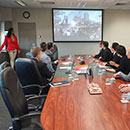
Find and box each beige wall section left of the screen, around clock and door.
[13,9,52,43]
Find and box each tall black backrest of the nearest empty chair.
[0,67,28,118]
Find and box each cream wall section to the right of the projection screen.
[103,10,130,48]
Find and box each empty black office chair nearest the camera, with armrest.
[0,67,42,130]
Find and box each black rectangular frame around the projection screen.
[52,8,104,43]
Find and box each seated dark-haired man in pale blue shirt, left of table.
[40,42,55,73]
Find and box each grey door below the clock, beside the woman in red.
[18,23,36,57]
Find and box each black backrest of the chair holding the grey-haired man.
[15,58,43,86]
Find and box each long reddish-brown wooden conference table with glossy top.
[41,55,130,130]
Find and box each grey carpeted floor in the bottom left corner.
[0,93,11,130]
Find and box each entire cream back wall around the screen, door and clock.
[12,9,130,56]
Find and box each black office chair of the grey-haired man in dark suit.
[15,58,46,95]
